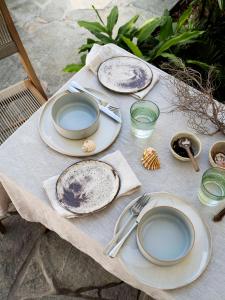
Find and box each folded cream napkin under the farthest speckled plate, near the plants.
[86,44,159,99]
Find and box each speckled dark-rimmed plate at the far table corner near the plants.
[98,56,153,94]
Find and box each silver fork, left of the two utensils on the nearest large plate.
[104,194,151,255]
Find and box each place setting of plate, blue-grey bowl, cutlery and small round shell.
[39,82,122,157]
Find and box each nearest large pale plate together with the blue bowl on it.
[114,192,212,290]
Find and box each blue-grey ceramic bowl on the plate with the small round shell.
[52,93,100,140]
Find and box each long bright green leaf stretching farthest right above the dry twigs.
[152,30,204,59]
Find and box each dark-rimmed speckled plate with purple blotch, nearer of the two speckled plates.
[56,160,120,215]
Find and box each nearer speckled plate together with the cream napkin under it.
[43,150,141,218]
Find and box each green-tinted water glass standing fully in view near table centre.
[130,100,160,138]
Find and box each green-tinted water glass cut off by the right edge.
[198,168,225,206]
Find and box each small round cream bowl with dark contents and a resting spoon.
[170,132,202,161]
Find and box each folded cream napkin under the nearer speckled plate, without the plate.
[43,151,141,218]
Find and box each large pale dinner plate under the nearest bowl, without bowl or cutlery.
[115,192,212,290]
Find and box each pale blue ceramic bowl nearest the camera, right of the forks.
[137,206,195,266]
